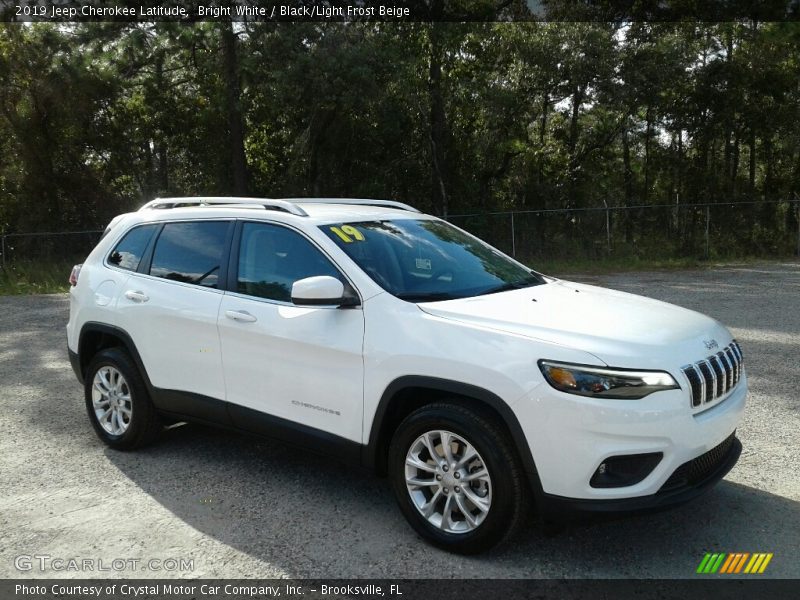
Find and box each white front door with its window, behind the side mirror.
[219,222,364,443]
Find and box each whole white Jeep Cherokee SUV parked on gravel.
[67,198,747,553]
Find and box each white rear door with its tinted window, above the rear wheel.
[118,220,234,412]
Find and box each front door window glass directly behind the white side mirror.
[236,223,344,302]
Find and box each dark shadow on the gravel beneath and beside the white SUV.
[105,425,800,578]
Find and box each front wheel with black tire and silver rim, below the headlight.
[388,403,527,554]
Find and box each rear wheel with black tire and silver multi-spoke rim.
[84,348,163,450]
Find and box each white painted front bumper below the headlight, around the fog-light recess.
[512,375,747,502]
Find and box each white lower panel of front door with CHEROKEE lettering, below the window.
[219,294,364,443]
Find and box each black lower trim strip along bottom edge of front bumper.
[539,438,742,520]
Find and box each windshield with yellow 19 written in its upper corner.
[320,219,544,302]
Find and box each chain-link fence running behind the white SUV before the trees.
[0,202,800,269]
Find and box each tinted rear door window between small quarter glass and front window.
[150,221,229,288]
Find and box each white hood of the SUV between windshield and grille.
[419,281,731,369]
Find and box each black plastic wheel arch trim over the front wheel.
[362,375,542,498]
